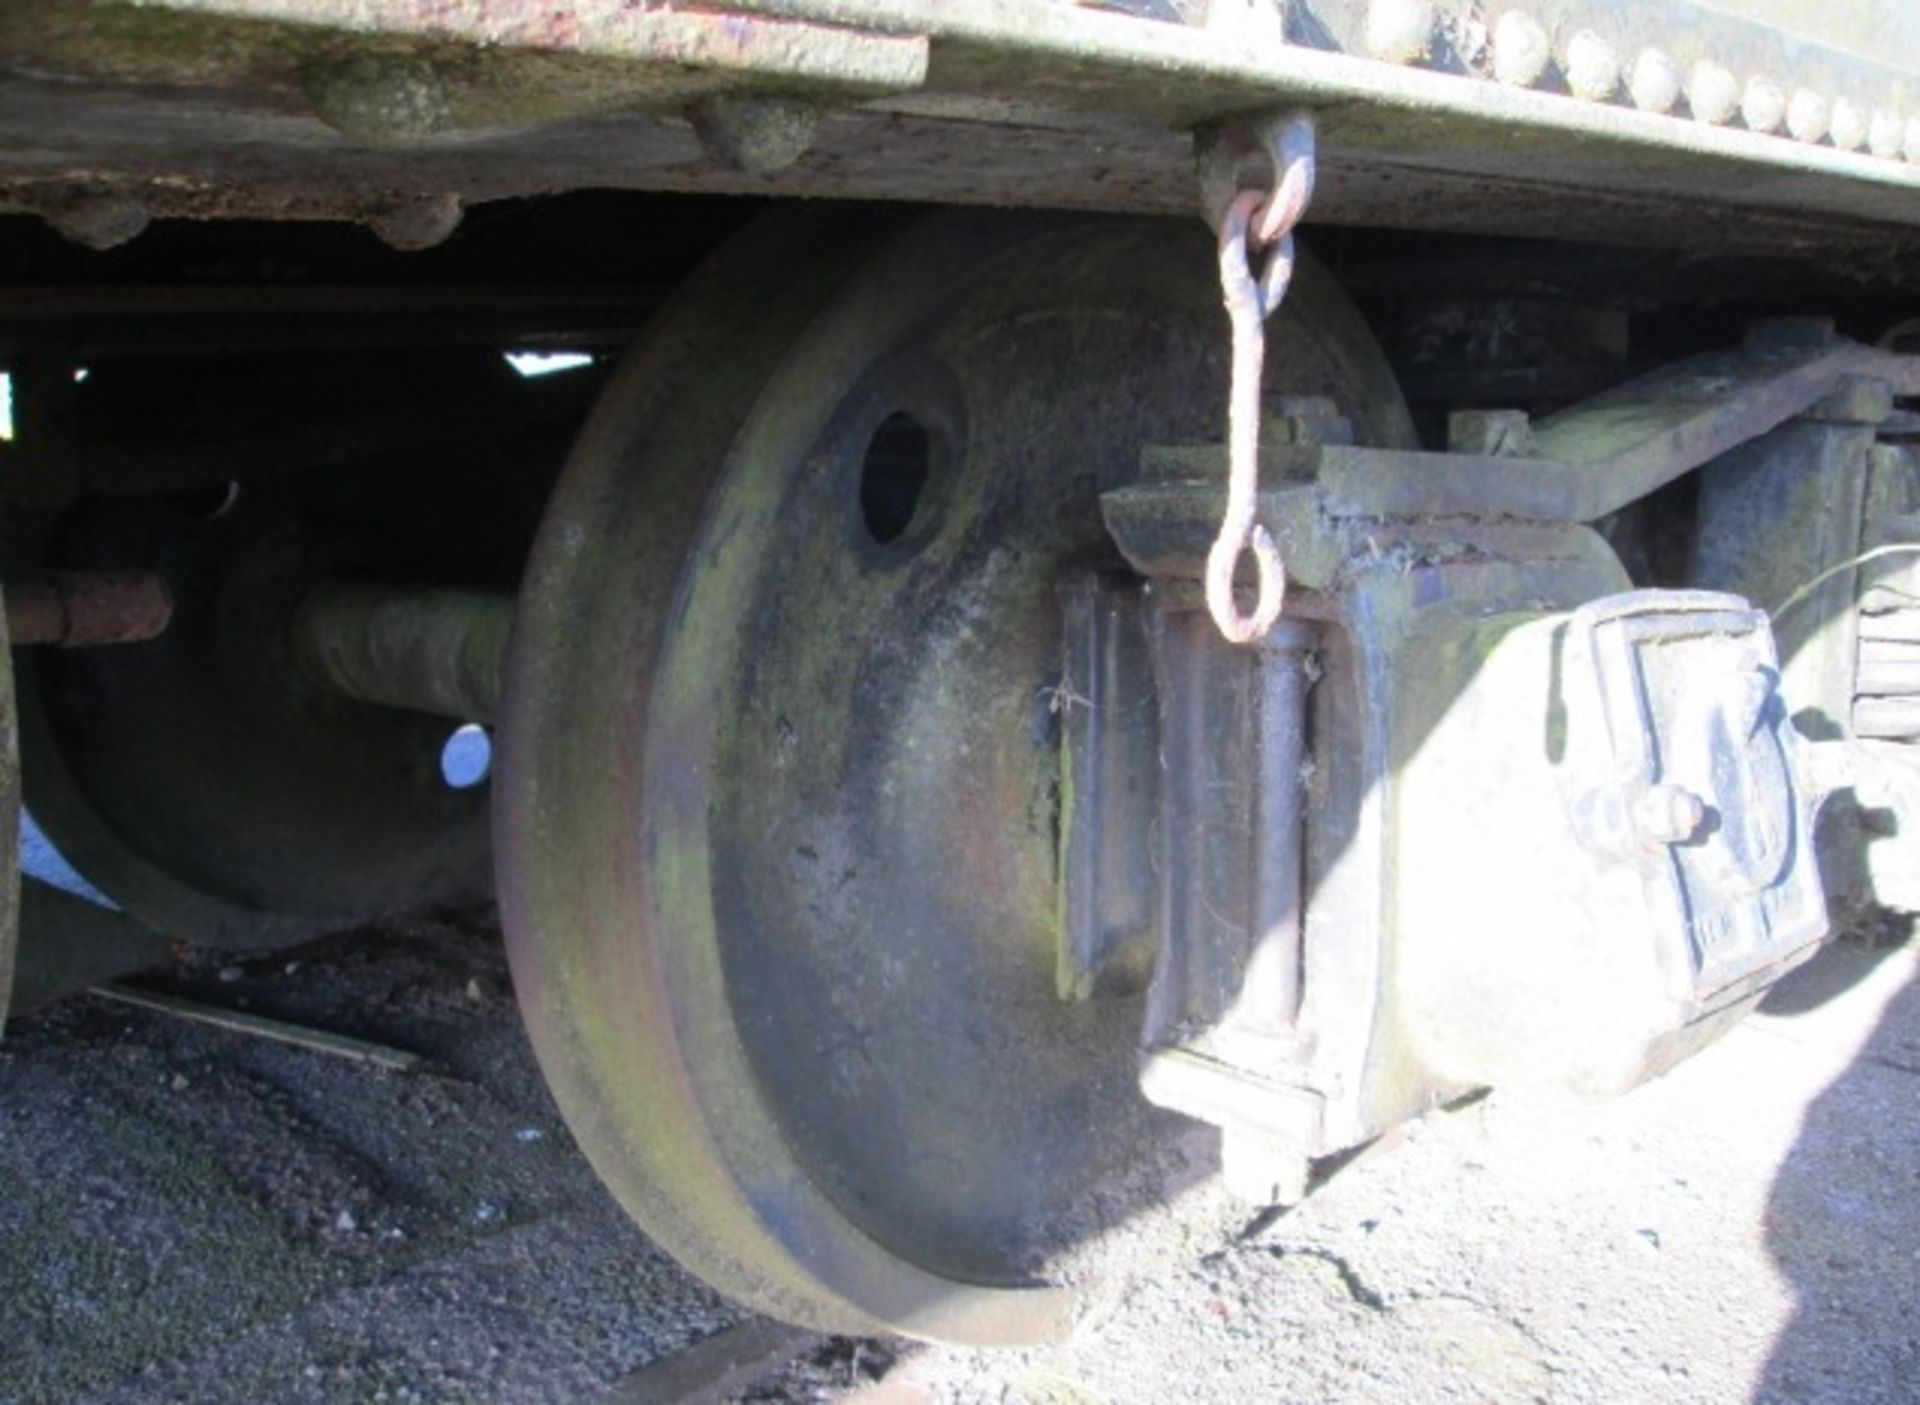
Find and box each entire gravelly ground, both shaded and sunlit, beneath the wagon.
[0,898,1920,1405]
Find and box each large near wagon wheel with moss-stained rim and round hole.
[495,213,1409,1344]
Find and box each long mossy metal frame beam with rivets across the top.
[0,0,1920,253]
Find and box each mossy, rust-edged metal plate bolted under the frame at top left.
[0,0,925,153]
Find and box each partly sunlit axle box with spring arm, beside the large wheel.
[1068,322,1920,1163]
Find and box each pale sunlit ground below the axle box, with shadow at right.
[893,928,1920,1405]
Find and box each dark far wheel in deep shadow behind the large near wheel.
[12,355,576,948]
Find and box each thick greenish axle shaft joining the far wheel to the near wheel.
[294,582,513,722]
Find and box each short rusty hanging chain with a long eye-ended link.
[1206,113,1313,643]
